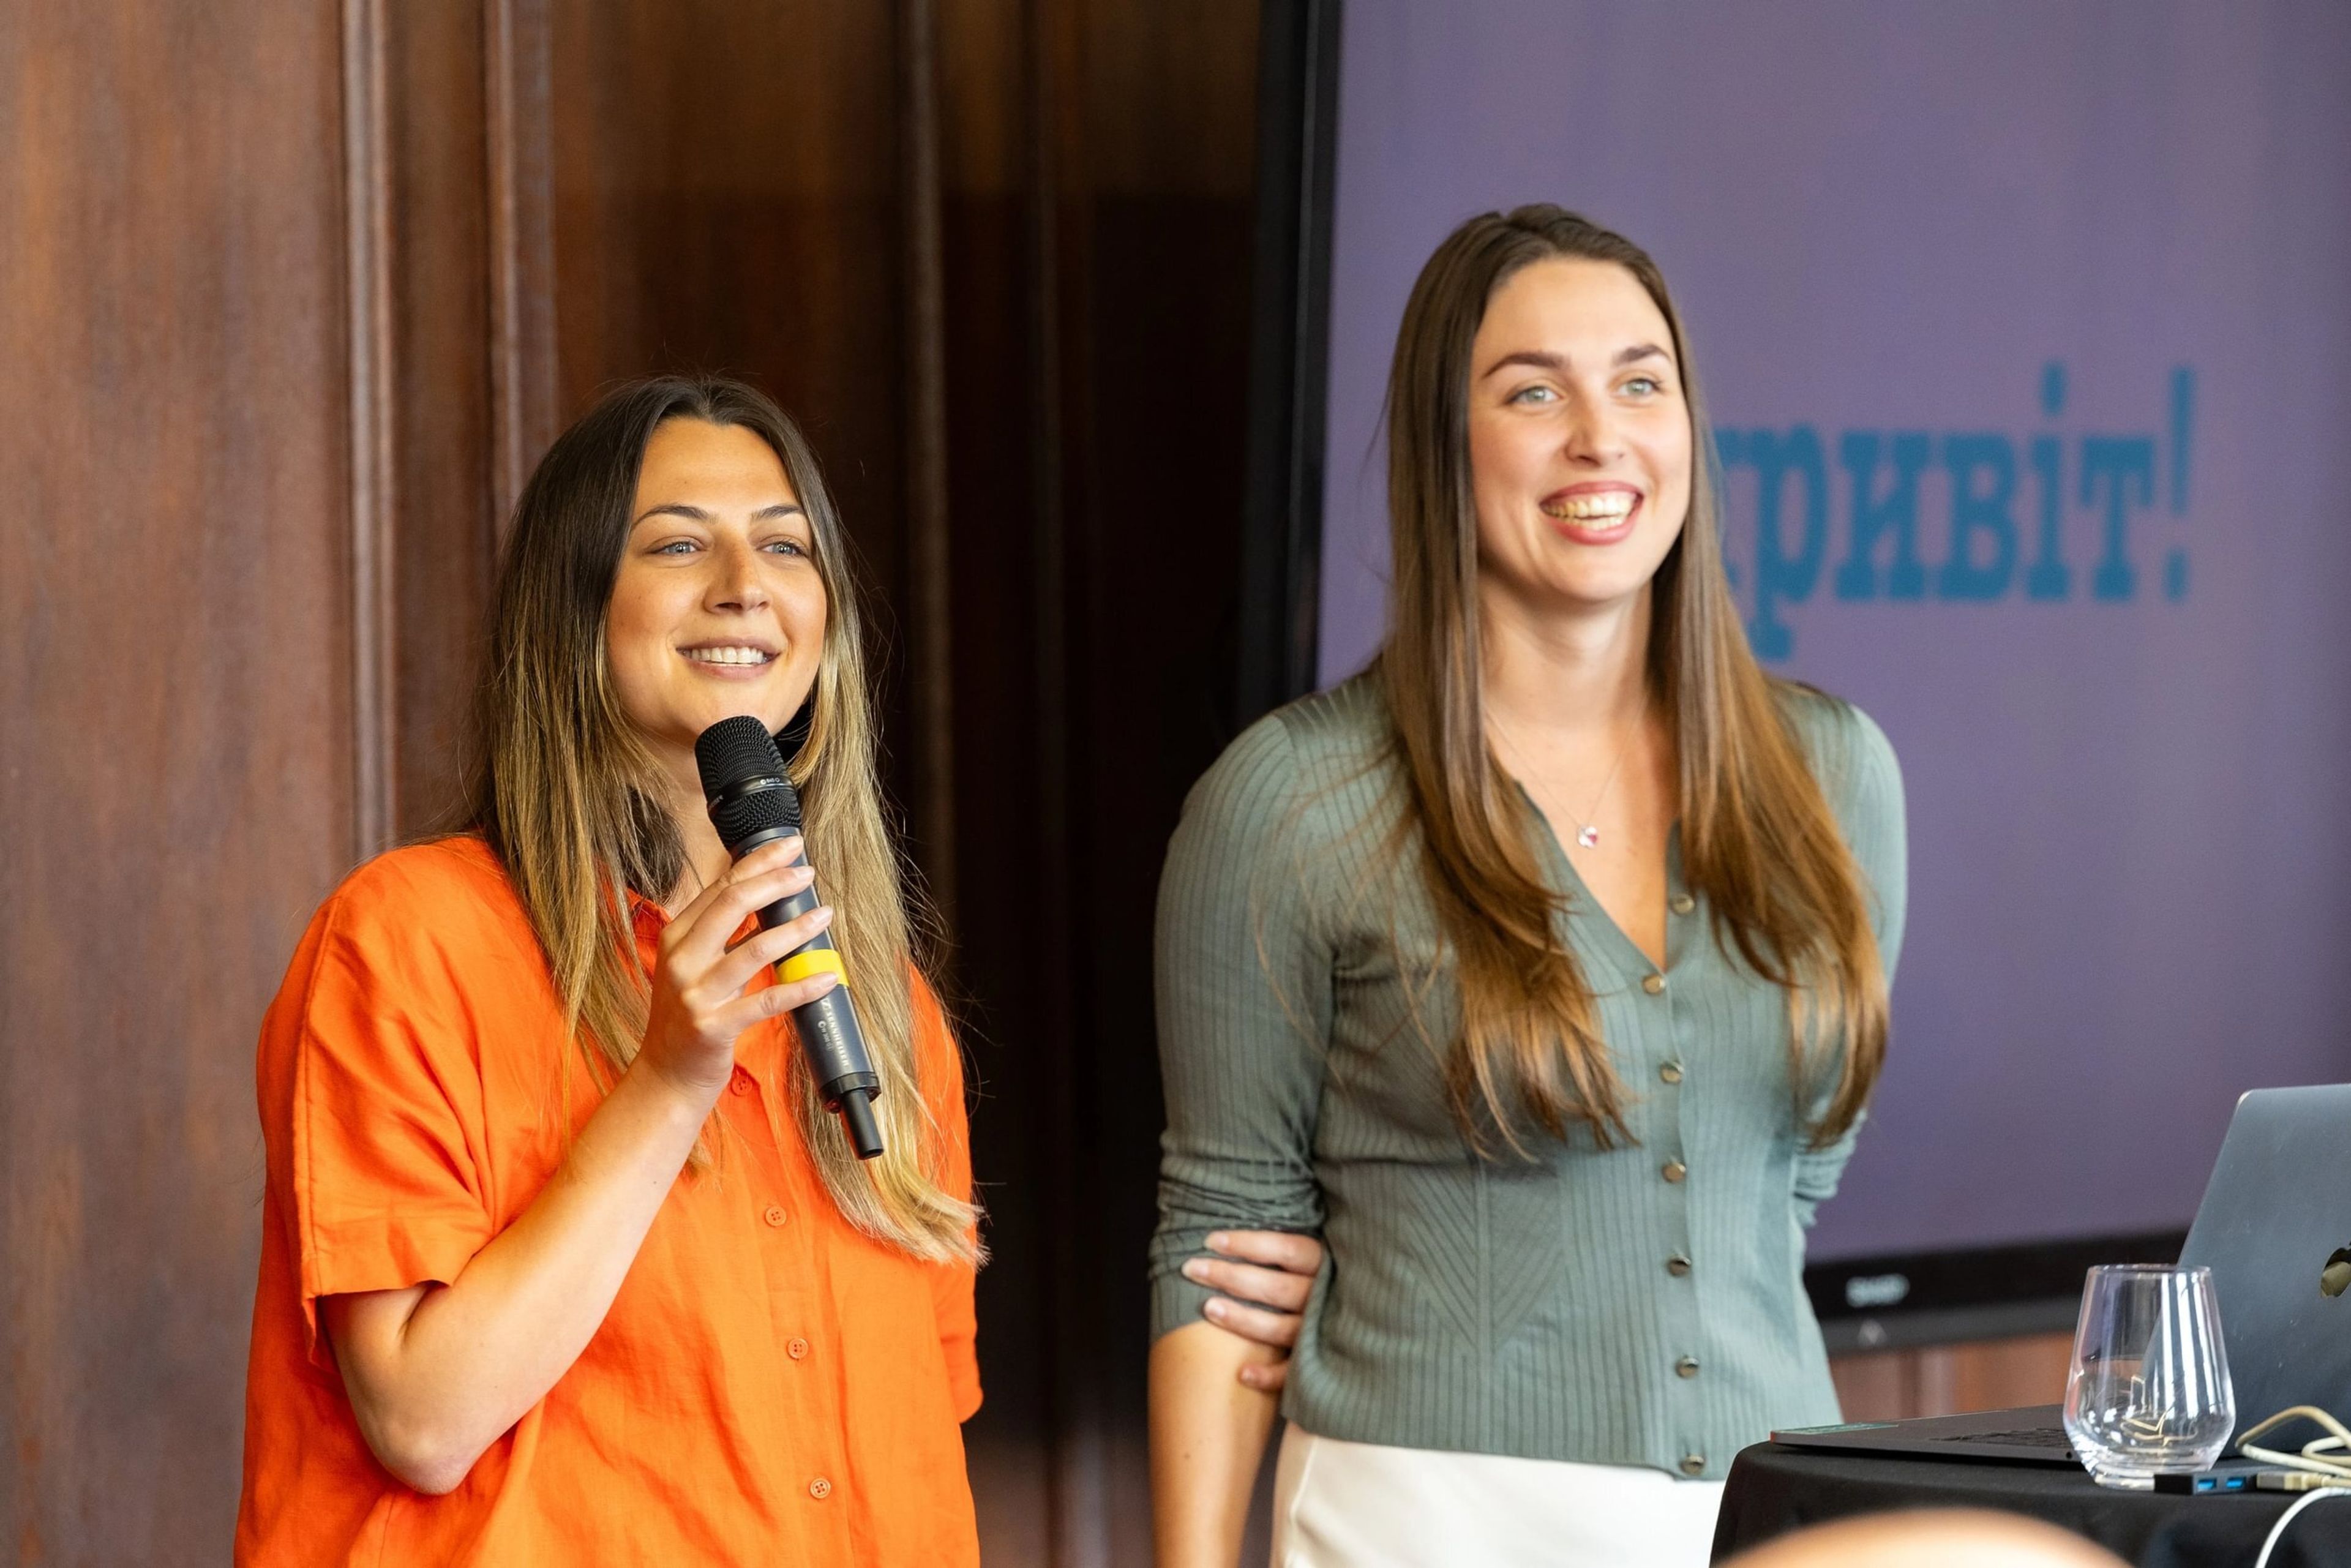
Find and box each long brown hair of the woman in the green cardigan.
[1373,204,1886,1150]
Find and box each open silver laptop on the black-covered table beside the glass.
[1771,1084,2351,1465]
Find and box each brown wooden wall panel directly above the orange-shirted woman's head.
[548,0,929,863]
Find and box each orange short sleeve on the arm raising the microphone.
[263,884,496,1364]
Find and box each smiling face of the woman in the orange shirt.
[604,418,825,778]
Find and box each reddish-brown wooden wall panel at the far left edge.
[0,0,358,1563]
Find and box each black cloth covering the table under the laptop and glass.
[1714,1444,2351,1568]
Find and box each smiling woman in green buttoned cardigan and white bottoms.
[1150,207,1904,1568]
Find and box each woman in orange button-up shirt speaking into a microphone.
[238,378,980,1568]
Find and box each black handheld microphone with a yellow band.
[694,715,882,1159]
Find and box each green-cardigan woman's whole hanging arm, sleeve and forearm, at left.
[1150,717,1330,1568]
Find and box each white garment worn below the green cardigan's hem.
[1272,1427,1723,1568]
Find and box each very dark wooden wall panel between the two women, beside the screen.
[940,0,1256,1566]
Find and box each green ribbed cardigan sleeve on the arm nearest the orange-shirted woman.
[1150,715,1330,1338]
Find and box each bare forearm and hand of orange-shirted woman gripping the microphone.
[320,839,834,1495]
